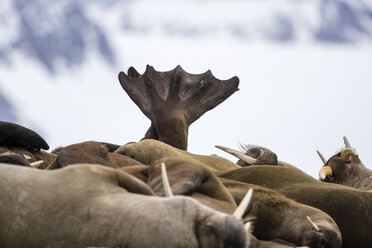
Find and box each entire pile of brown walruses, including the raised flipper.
[0,66,372,248]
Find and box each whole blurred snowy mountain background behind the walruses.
[0,0,372,178]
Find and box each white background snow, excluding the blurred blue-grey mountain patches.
[0,1,372,178]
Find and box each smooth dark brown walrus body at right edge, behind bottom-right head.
[219,166,372,248]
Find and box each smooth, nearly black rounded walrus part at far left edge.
[0,121,49,150]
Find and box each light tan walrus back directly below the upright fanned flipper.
[115,139,240,173]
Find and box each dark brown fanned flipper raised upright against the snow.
[119,66,239,150]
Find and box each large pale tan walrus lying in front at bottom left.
[0,164,247,248]
